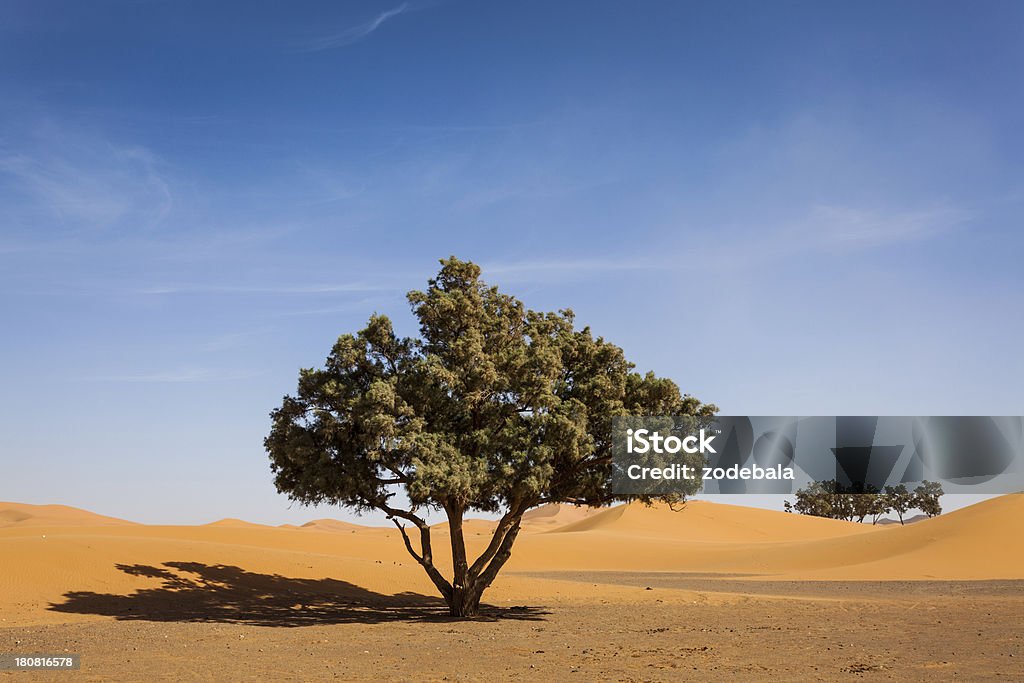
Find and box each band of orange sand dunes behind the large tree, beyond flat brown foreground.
[0,495,1024,623]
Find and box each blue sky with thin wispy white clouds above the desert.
[0,0,1024,522]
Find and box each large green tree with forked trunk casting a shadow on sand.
[264,257,717,616]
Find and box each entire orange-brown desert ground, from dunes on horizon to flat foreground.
[0,494,1024,681]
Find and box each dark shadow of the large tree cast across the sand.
[49,562,548,627]
